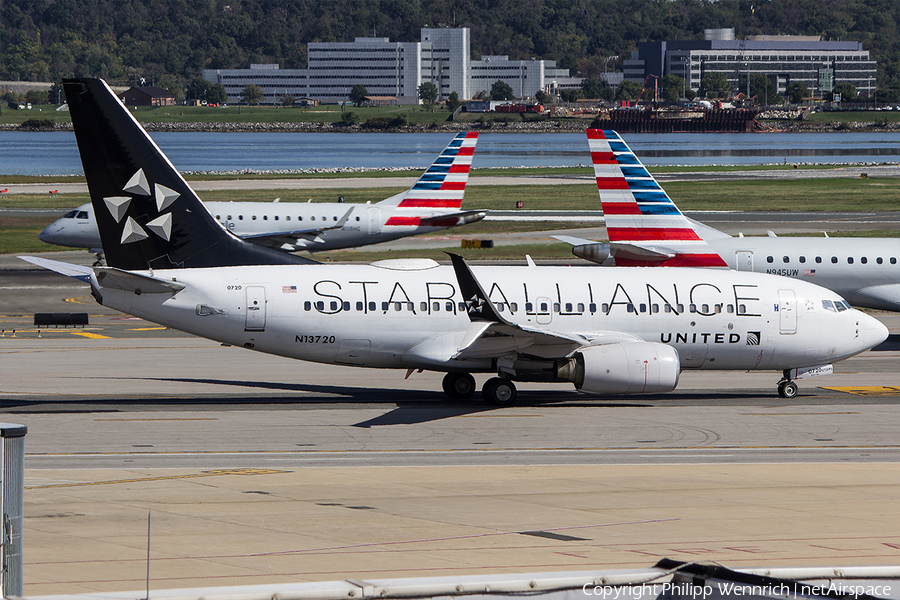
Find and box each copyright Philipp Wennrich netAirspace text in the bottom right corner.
[581,581,892,600]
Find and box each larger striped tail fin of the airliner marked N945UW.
[587,129,728,267]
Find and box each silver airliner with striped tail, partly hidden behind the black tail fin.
[38,133,485,258]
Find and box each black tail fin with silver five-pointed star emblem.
[63,79,311,270]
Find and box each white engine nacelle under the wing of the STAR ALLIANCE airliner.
[556,342,681,394]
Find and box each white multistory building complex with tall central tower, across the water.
[203,27,581,104]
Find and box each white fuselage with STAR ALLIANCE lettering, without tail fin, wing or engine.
[94,262,886,380]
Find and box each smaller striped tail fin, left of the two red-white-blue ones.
[378,132,478,210]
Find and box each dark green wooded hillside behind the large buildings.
[0,0,900,97]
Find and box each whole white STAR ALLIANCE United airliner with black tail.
[23,79,887,405]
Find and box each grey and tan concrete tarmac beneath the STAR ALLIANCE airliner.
[0,252,900,595]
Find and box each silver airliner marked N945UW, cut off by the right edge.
[557,129,900,311]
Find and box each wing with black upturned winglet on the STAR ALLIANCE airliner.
[450,254,643,359]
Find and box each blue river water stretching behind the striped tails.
[0,131,900,175]
